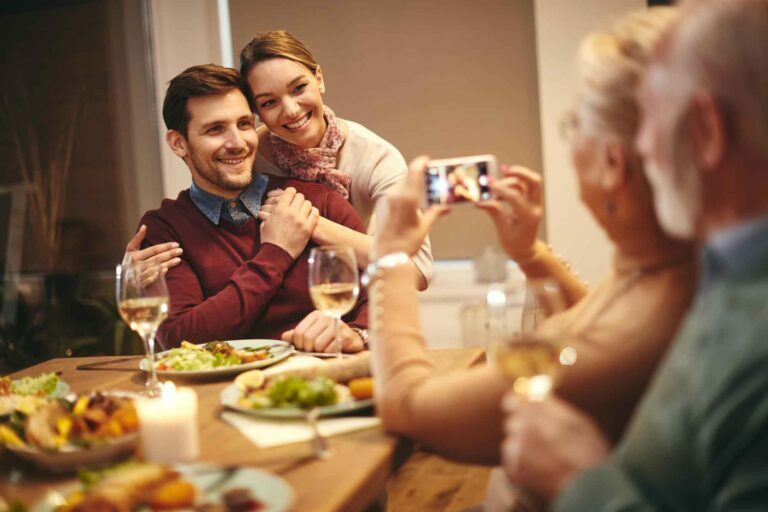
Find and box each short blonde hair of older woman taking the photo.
[579,7,678,148]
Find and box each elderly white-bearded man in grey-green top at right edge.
[503,0,768,511]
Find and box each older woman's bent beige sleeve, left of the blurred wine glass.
[369,266,506,464]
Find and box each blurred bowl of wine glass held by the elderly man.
[495,279,576,401]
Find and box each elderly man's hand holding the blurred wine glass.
[501,391,610,502]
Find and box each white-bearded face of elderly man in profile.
[637,64,701,239]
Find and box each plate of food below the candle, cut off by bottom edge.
[32,462,295,512]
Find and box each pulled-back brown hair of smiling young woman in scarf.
[240,30,320,78]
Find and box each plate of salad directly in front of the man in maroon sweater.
[139,339,293,378]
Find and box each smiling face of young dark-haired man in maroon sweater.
[183,89,259,198]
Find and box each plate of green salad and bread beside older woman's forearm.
[221,354,373,418]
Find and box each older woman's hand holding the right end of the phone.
[477,165,543,262]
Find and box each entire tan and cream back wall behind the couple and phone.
[152,0,645,283]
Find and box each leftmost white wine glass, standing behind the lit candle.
[115,261,168,398]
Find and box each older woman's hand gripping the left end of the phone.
[371,156,449,261]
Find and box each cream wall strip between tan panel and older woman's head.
[535,0,645,283]
